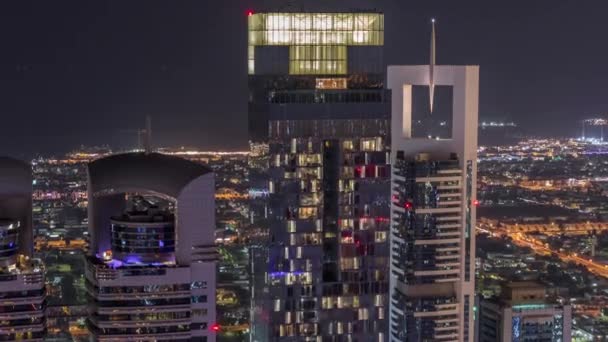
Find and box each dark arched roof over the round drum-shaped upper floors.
[88,152,212,198]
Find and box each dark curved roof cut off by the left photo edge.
[0,157,33,193]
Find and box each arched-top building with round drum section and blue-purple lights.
[86,153,219,341]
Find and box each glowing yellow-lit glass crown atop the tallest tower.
[248,13,384,75]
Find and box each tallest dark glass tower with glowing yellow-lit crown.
[248,12,390,341]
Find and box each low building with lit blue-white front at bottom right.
[476,282,572,342]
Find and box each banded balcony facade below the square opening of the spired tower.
[391,156,470,341]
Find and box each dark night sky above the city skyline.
[0,0,608,156]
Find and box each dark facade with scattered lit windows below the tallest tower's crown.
[268,132,390,341]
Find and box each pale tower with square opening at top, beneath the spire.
[387,63,479,341]
